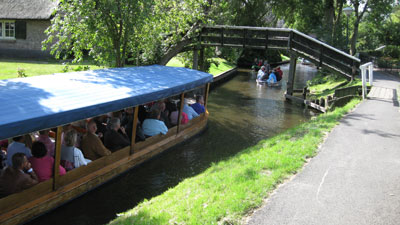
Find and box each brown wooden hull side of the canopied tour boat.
[0,113,208,224]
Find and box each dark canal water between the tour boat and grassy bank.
[29,65,316,225]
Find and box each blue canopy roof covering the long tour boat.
[0,65,213,140]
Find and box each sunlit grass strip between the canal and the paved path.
[110,99,359,224]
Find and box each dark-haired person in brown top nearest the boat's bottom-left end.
[0,152,39,197]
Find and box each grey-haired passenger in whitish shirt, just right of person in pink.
[61,129,91,170]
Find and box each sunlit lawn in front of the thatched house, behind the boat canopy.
[0,60,102,80]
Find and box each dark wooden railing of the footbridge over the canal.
[200,25,360,77]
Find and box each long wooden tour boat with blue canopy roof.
[0,65,213,224]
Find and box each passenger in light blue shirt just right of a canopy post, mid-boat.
[143,109,168,137]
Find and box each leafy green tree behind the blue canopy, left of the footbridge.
[44,0,212,67]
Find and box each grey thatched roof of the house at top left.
[0,0,58,19]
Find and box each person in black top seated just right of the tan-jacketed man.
[104,117,130,152]
